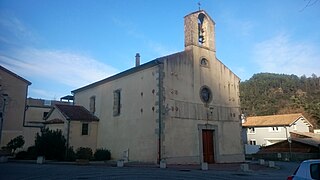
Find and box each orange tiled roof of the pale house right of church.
[242,113,312,127]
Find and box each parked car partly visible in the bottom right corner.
[288,159,320,180]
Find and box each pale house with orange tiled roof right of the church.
[242,114,312,146]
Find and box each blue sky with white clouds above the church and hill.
[0,0,320,100]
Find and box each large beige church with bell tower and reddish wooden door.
[71,10,244,163]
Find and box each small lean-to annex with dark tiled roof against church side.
[44,104,99,151]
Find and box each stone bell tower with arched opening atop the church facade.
[184,10,216,51]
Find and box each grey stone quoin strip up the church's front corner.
[157,61,163,164]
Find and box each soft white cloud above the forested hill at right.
[253,34,320,76]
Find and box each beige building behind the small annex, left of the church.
[23,98,70,149]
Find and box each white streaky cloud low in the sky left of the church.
[0,48,117,88]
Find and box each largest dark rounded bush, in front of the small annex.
[35,128,66,160]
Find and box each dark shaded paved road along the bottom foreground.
[0,162,298,180]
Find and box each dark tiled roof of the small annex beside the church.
[55,104,99,121]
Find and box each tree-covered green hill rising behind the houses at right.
[240,73,320,127]
